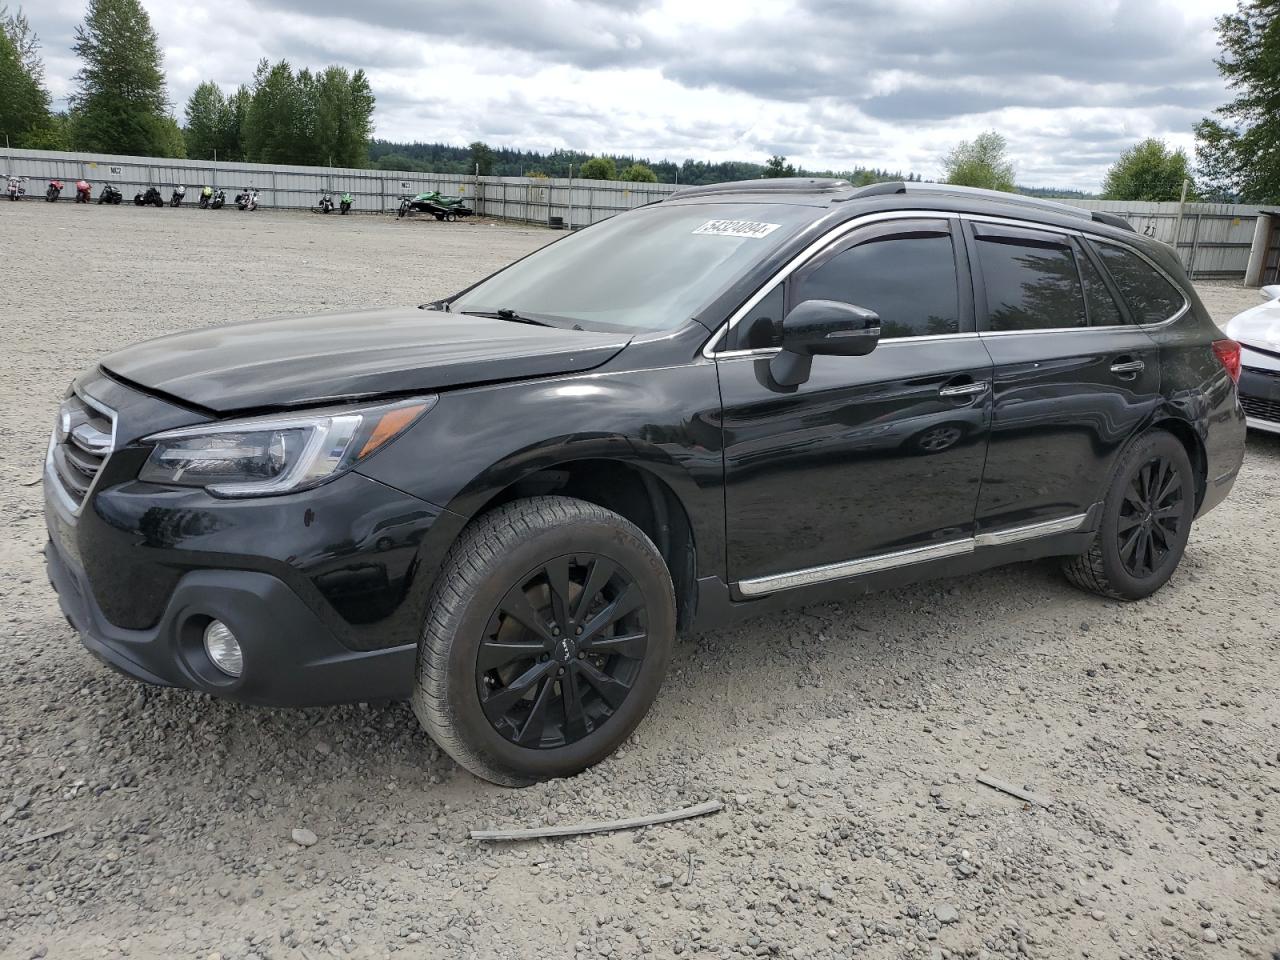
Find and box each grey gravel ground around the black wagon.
[0,202,1280,960]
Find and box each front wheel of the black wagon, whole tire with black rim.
[412,497,676,787]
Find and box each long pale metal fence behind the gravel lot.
[0,150,1258,278]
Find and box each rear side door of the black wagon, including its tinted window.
[966,219,1160,539]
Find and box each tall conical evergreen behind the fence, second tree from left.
[70,0,183,156]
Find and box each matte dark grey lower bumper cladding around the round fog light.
[45,540,417,707]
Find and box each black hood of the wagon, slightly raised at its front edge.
[101,307,630,413]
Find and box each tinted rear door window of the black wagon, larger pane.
[978,239,1085,330]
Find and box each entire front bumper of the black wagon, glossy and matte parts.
[45,372,465,705]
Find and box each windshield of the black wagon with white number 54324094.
[449,204,814,330]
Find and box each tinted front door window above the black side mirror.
[792,234,960,338]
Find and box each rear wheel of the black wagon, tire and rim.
[1062,430,1196,600]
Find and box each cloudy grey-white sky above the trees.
[24,0,1235,189]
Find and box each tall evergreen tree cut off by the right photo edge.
[1196,0,1280,204]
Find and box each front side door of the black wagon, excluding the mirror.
[718,219,992,595]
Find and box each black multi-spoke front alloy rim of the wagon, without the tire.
[476,553,649,750]
